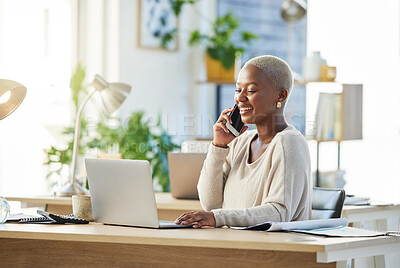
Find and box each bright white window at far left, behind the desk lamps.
[0,0,73,195]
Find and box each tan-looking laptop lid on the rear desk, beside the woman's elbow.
[168,152,207,199]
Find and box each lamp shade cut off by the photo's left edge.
[0,79,26,120]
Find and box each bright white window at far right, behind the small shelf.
[307,0,400,203]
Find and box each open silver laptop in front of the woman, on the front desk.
[85,158,192,228]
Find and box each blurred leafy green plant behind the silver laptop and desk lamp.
[43,64,179,192]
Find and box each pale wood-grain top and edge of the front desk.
[0,223,400,255]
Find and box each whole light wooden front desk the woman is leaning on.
[0,223,400,268]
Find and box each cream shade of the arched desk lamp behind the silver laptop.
[92,75,131,114]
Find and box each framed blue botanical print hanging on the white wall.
[138,0,178,51]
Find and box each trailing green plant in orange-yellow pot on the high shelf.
[161,0,258,82]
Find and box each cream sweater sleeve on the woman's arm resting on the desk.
[212,135,311,226]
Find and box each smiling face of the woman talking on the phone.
[235,64,279,124]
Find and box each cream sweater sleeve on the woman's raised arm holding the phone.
[197,144,230,211]
